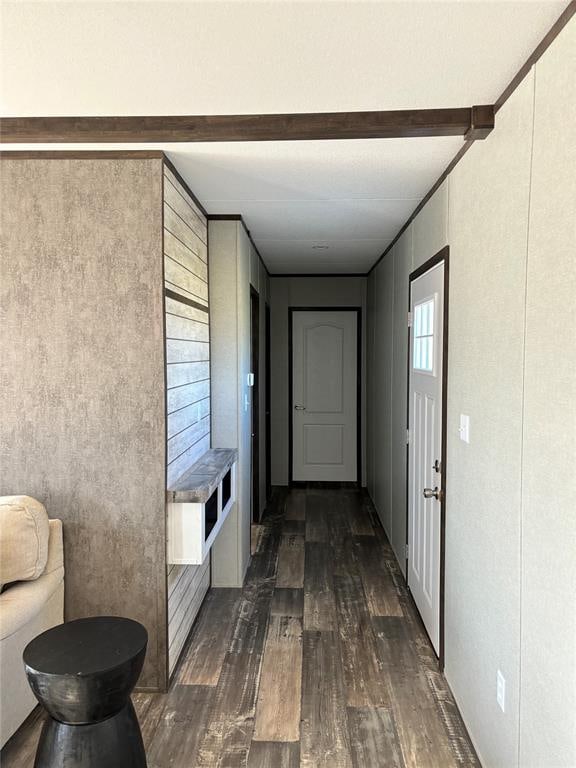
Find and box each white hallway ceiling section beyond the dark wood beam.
[169,137,462,272]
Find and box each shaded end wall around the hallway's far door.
[270,276,366,485]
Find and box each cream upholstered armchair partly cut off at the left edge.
[0,496,64,747]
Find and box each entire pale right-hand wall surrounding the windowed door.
[367,20,576,768]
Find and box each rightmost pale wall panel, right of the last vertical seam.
[520,19,576,768]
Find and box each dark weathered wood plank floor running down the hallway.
[1,488,479,768]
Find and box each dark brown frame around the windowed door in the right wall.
[406,245,450,671]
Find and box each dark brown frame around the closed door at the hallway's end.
[288,306,362,488]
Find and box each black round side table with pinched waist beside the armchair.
[23,616,148,768]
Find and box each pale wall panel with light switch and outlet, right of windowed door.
[445,75,533,766]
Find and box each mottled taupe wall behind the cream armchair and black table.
[0,158,166,687]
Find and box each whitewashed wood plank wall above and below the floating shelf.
[164,160,210,673]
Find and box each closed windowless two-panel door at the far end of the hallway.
[292,310,358,482]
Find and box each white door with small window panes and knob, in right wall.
[408,262,444,653]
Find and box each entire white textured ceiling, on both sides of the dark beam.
[0,0,568,272]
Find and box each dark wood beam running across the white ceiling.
[0,105,494,144]
